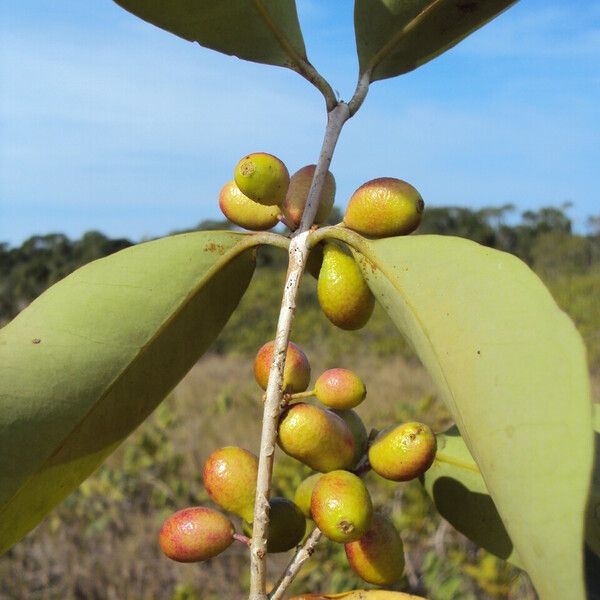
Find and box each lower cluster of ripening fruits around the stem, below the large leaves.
[160,342,436,585]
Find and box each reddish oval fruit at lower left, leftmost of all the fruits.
[158,506,234,562]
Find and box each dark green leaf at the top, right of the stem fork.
[354,0,516,81]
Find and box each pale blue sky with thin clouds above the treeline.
[0,0,600,244]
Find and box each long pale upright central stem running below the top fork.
[249,102,350,600]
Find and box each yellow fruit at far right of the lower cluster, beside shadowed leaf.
[369,423,437,481]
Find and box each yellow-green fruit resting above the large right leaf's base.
[344,177,425,237]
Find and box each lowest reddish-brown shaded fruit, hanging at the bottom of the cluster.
[345,513,404,585]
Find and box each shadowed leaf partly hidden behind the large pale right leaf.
[423,427,522,568]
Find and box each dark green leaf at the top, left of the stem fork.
[115,0,308,70]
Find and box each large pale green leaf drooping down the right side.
[340,230,593,599]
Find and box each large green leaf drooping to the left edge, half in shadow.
[0,232,254,553]
